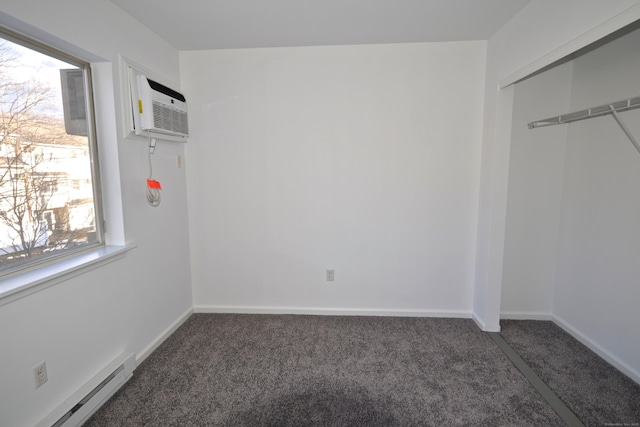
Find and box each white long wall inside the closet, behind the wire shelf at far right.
[553,30,640,381]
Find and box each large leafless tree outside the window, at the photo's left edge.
[0,42,79,264]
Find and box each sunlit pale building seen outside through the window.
[0,120,95,266]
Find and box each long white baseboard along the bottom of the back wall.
[193,305,471,319]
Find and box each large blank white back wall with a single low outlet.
[181,42,485,316]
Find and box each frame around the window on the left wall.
[0,24,106,278]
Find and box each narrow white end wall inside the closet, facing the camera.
[501,62,573,319]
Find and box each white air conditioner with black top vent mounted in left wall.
[129,69,189,141]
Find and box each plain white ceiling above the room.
[111,0,530,50]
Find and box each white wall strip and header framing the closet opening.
[473,0,640,331]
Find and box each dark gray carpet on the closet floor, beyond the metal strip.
[500,320,640,427]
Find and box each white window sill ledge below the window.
[0,245,135,306]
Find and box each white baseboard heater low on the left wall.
[37,354,136,427]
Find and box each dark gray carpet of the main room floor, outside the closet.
[87,314,563,426]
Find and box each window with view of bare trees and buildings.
[0,28,102,276]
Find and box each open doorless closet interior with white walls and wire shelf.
[501,24,640,382]
